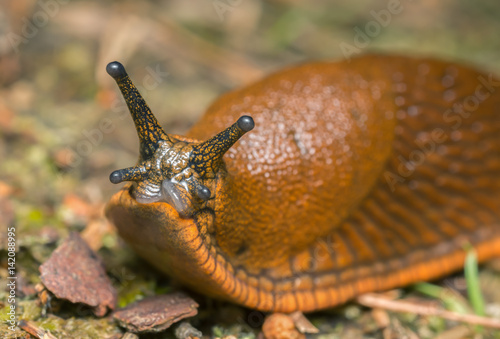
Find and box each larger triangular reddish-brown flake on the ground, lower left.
[40,232,116,317]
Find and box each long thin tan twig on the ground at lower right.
[357,293,500,329]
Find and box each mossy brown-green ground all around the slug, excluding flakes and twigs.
[0,0,500,339]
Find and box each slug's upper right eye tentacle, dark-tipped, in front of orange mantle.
[190,115,255,178]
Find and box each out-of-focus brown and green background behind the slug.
[0,0,500,338]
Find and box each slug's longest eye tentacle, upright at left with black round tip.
[106,61,170,159]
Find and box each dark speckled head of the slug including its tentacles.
[106,61,254,218]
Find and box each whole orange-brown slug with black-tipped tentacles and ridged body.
[106,55,500,312]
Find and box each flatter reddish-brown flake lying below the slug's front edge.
[113,292,198,333]
